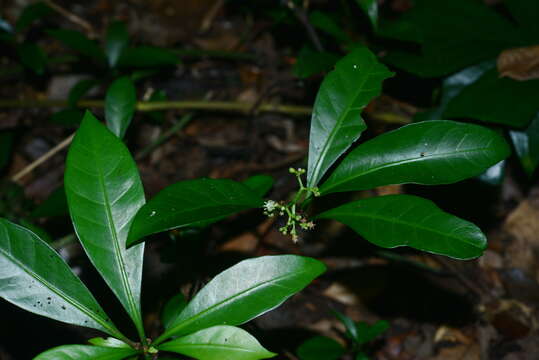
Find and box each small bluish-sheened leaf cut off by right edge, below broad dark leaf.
[509,113,539,177]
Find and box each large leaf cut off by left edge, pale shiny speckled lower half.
[0,219,119,335]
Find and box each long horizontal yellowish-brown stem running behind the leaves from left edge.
[0,99,312,116]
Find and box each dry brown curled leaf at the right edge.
[497,45,539,81]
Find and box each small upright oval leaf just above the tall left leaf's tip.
[105,76,137,139]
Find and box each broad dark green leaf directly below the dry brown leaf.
[444,69,539,127]
